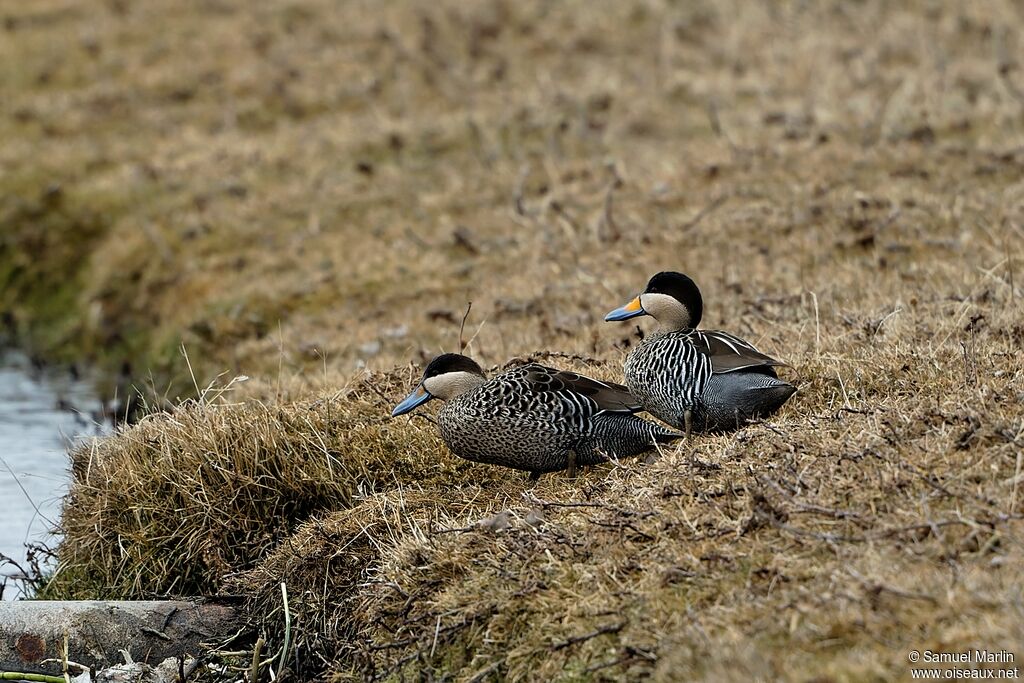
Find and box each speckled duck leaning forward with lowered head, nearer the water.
[391,353,682,479]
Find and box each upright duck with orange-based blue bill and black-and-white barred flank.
[604,272,797,436]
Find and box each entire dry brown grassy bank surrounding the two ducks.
[0,0,1024,680]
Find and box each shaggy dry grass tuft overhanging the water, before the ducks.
[47,373,507,598]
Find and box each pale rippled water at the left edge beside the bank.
[0,351,108,599]
